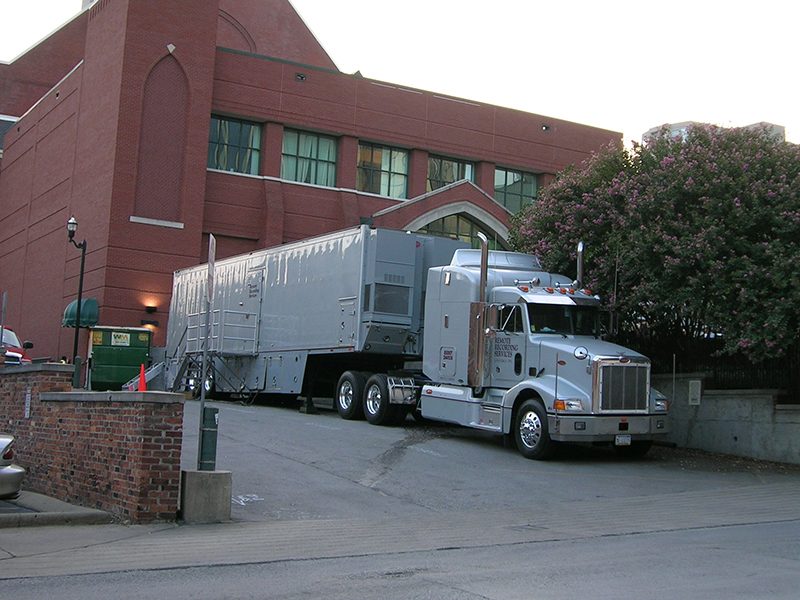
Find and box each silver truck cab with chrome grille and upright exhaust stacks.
[419,250,667,458]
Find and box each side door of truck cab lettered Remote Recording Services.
[489,304,528,388]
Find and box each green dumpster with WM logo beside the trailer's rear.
[89,326,153,390]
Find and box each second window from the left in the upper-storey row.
[281,129,336,187]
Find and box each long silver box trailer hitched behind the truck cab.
[165,225,468,404]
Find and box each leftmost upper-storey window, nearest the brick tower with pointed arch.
[208,117,261,175]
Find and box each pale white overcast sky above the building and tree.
[0,0,800,143]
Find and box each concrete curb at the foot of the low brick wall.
[0,492,114,528]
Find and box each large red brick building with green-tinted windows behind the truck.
[0,0,622,357]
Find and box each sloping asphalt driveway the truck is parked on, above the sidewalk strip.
[183,402,800,521]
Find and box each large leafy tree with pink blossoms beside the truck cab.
[511,126,800,361]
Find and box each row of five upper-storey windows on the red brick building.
[208,116,537,213]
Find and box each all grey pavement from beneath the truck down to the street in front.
[0,402,800,600]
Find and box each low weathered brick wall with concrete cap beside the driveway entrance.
[0,364,183,523]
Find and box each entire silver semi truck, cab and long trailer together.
[165,225,668,459]
